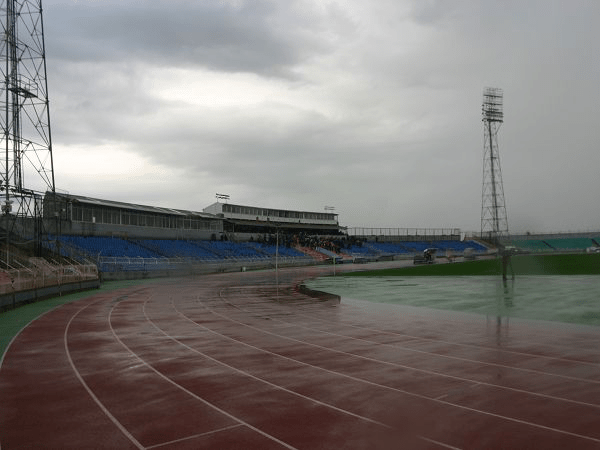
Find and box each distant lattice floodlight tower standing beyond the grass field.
[481,87,508,244]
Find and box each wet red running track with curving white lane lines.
[0,269,600,450]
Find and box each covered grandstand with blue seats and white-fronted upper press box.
[36,192,340,272]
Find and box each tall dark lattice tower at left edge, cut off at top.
[0,0,55,258]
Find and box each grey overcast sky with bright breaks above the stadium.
[39,0,600,231]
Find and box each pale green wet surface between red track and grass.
[306,275,600,327]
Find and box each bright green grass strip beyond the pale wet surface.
[343,253,600,277]
